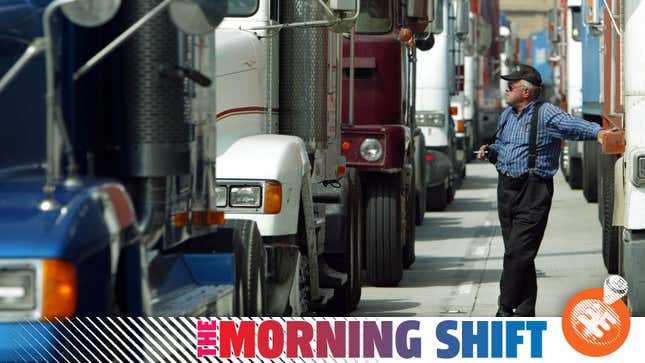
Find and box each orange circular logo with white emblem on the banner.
[562,280,630,357]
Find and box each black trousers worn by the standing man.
[497,174,553,316]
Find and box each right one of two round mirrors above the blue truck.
[170,0,228,35]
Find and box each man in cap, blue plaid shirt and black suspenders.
[477,64,609,317]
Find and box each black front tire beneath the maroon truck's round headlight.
[363,174,403,286]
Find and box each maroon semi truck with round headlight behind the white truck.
[342,0,434,286]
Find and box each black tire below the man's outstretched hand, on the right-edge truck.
[598,153,619,274]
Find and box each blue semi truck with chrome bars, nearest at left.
[0,0,264,361]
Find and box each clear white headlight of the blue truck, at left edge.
[0,268,36,310]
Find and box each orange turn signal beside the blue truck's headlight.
[42,260,77,320]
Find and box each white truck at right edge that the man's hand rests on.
[583,0,645,316]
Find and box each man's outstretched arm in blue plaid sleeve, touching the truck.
[543,103,608,142]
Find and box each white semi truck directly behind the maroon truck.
[415,0,469,211]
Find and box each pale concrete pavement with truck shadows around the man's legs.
[353,162,607,316]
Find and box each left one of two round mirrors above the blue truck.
[62,0,121,28]
